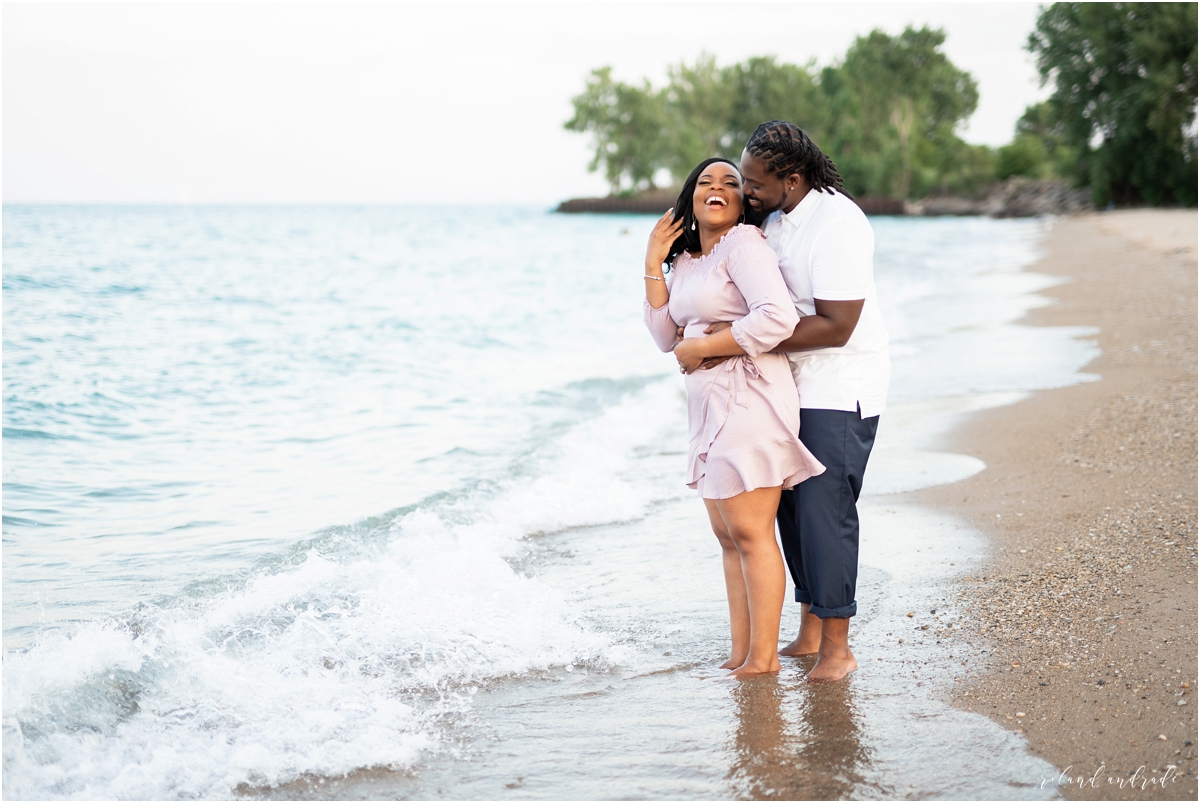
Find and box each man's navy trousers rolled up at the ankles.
[776,409,880,619]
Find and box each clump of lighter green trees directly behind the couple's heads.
[565,36,994,198]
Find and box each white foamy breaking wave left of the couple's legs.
[4,382,683,798]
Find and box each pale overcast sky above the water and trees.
[4,2,1046,203]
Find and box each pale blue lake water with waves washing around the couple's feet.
[4,206,1097,798]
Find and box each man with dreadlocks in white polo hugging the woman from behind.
[742,120,890,682]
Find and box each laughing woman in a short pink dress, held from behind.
[646,158,824,677]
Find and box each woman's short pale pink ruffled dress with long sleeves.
[646,226,824,499]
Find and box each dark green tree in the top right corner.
[1028,2,1196,205]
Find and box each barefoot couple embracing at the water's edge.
[646,120,890,682]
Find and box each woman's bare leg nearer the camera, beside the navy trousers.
[706,487,786,677]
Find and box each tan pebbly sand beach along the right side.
[911,210,1198,799]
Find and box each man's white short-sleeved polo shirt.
[763,190,892,418]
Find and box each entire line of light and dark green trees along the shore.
[564,2,1196,205]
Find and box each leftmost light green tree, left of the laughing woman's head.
[563,67,667,194]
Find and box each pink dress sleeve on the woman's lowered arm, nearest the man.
[728,232,800,356]
